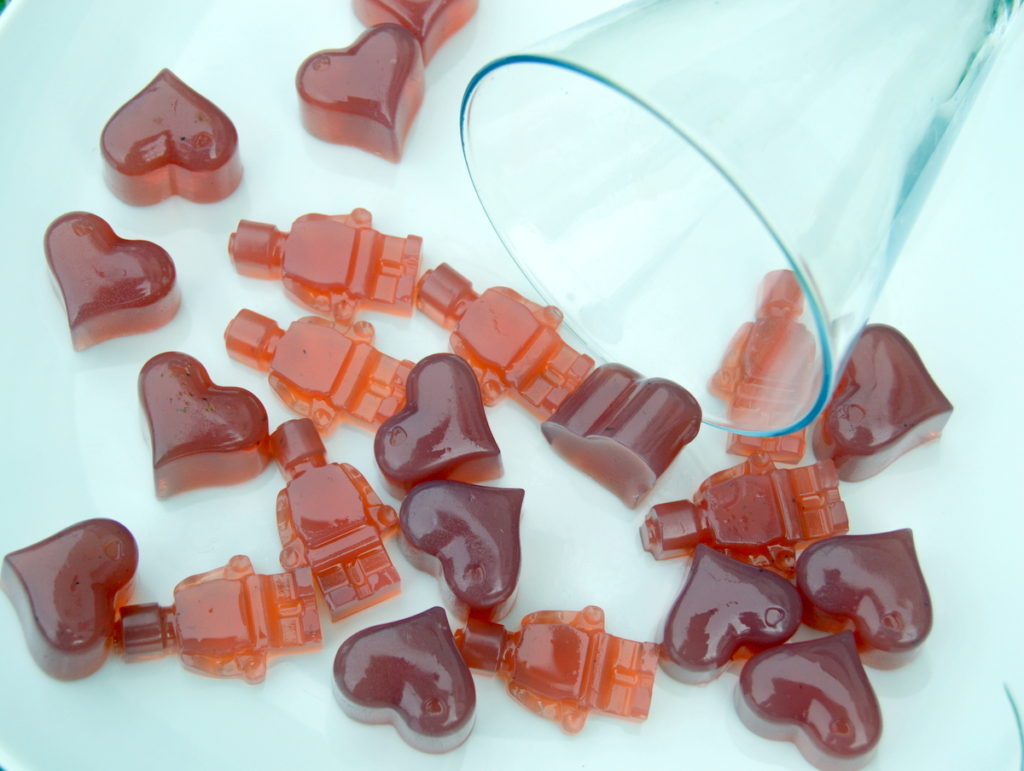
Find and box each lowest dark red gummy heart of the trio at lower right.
[736,632,882,769]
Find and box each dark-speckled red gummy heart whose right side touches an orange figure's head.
[138,351,270,498]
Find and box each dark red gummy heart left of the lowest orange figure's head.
[334,607,476,753]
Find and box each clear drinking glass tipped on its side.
[462,0,1021,435]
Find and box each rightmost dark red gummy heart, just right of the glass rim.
[814,324,953,482]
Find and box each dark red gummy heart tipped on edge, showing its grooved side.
[541,365,700,509]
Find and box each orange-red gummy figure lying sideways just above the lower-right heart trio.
[640,453,850,576]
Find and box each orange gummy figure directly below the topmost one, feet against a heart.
[224,309,413,432]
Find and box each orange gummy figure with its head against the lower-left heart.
[115,555,323,683]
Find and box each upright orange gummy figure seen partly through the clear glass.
[709,270,814,463]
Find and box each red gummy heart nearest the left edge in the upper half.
[43,212,181,350]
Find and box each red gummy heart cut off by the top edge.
[352,0,477,63]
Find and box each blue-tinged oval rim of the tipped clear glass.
[459,53,835,437]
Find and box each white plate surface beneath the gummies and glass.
[0,0,1024,771]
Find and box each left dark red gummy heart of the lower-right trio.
[660,544,801,683]
